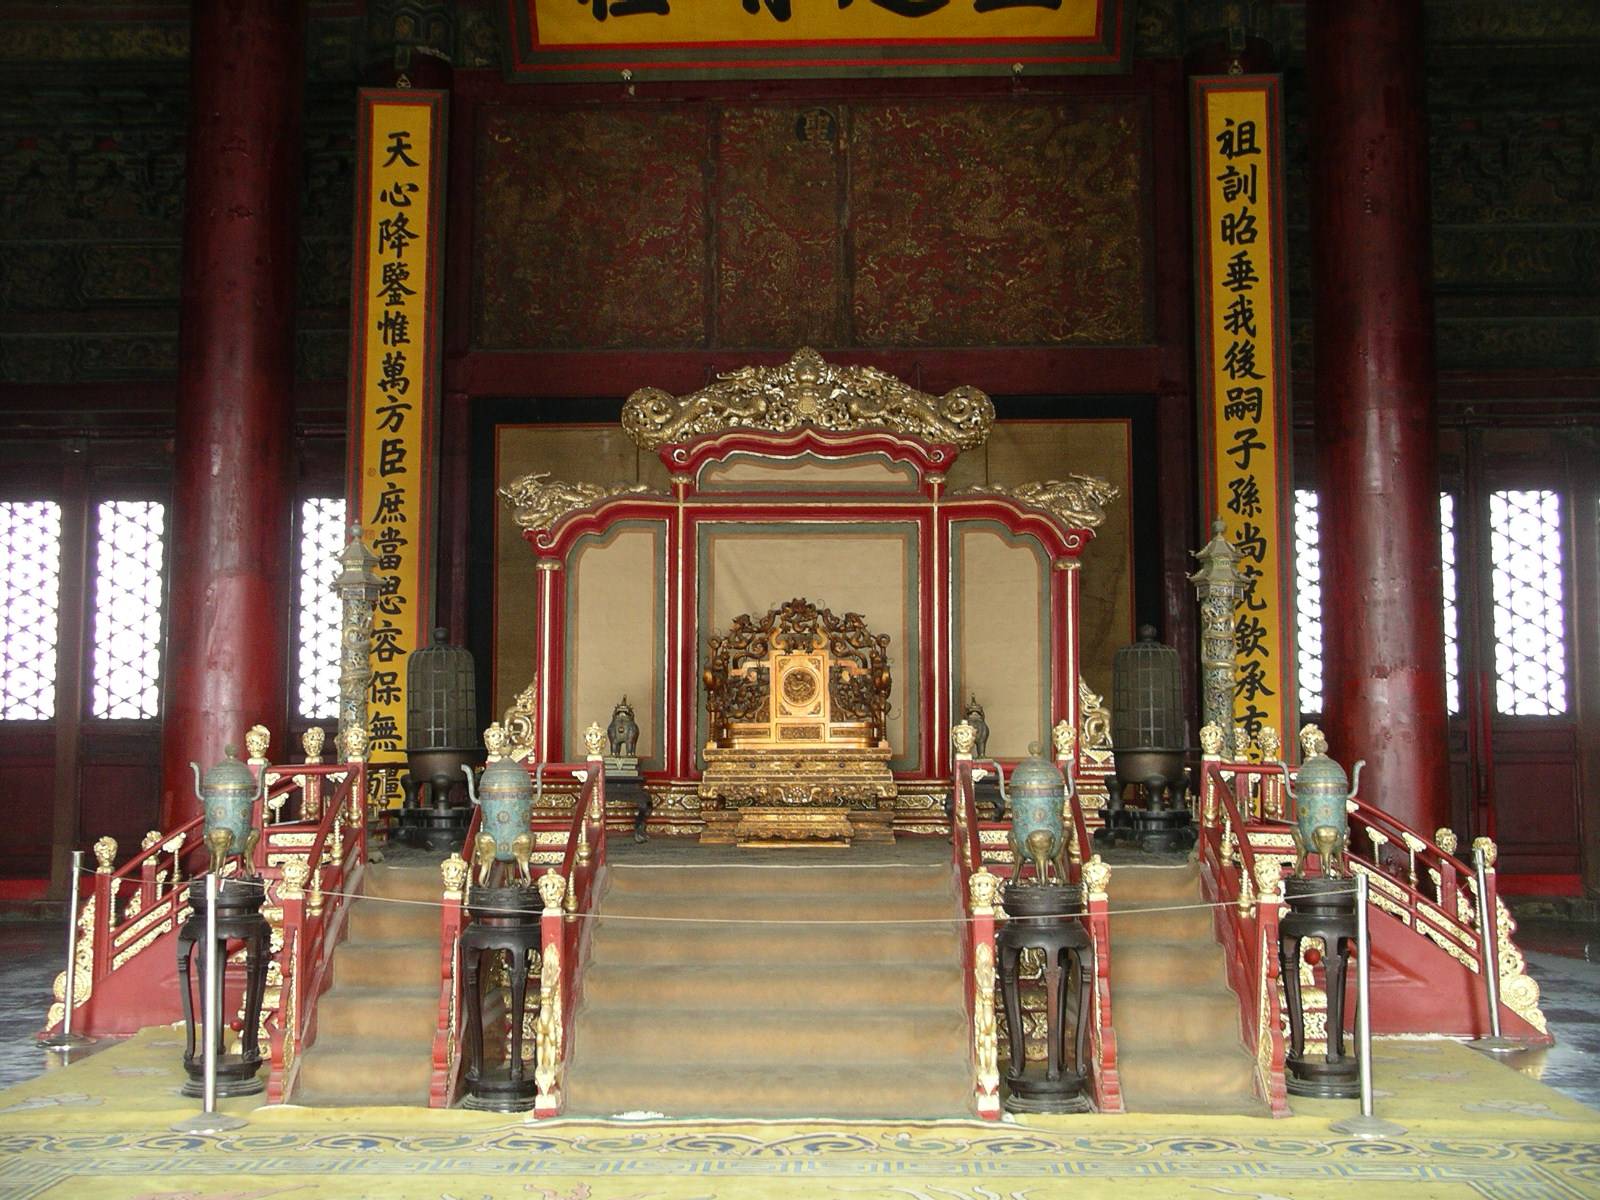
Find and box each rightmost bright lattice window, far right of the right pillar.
[1490,491,1566,717]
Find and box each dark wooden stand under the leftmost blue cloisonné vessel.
[178,875,272,1096]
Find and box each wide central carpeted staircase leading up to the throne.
[566,851,971,1118]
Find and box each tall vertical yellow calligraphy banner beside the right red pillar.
[1190,75,1296,744]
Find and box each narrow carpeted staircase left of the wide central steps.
[290,856,440,1107]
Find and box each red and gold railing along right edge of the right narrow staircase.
[1198,758,1290,1117]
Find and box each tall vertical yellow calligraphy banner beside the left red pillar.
[346,90,445,800]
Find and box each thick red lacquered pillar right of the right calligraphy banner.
[1306,0,1450,835]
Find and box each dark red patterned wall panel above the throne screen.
[474,98,1150,349]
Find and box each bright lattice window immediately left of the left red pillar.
[91,501,166,720]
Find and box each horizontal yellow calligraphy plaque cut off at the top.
[507,0,1128,82]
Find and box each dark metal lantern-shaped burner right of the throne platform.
[1101,626,1194,850]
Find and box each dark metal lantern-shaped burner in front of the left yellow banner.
[403,629,478,850]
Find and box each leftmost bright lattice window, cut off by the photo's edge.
[0,501,61,722]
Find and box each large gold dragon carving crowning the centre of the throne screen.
[622,355,995,450]
